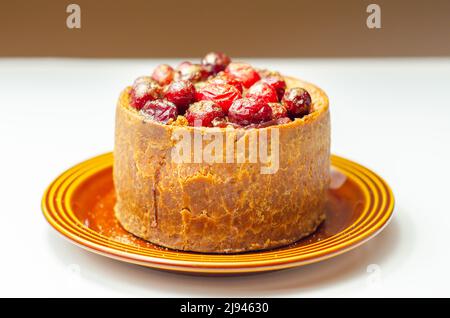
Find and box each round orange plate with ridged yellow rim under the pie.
[42,153,394,274]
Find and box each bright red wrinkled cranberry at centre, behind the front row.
[197,84,242,112]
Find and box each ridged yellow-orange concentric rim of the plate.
[42,153,394,274]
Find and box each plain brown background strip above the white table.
[0,0,450,57]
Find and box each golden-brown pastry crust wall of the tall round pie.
[114,77,330,253]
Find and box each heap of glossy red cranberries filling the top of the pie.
[130,52,311,127]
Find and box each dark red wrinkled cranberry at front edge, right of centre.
[228,98,272,126]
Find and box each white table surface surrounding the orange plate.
[0,59,450,297]
